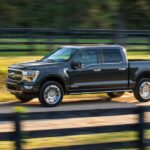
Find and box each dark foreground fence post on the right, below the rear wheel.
[138,107,145,150]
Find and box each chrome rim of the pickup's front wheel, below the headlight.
[44,85,61,104]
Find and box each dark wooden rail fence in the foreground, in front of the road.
[0,107,150,150]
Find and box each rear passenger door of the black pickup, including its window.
[99,48,128,90]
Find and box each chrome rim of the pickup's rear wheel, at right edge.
[140,81,150,99]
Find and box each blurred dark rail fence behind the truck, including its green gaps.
[0,28,150,52]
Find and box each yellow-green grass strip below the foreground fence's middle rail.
[0,132,137,150]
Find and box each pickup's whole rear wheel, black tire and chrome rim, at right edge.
[134,78,150,102]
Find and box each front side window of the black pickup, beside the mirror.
[74,49,97,65]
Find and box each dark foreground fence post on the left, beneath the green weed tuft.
[14,113,22,150]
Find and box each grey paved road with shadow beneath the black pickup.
[0,93,150,113]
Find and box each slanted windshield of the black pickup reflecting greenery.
[42,48,77,62]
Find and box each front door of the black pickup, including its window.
[68,49,101,91]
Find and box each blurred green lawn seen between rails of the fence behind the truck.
[0,37,150,56]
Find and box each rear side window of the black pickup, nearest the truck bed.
[102,49,122,63]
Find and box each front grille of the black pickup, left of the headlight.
[8,69,22,81]
